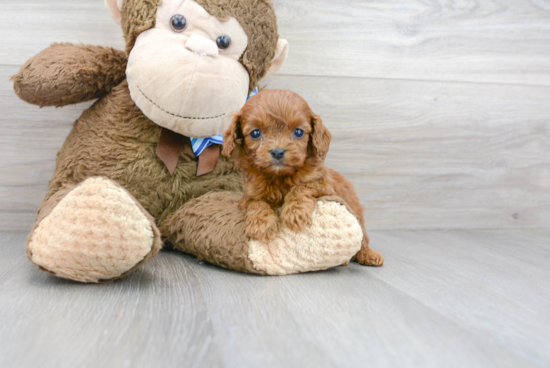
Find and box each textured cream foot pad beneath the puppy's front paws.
[248,201,363,275]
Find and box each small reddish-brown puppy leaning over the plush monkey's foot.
[222,90,384,266]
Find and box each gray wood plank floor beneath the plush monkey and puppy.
[0,230,550,367]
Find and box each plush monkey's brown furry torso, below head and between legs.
[46,81,247,225]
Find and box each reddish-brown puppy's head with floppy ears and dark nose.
[222,90,332,176]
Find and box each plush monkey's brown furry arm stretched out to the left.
[12,43,128,107]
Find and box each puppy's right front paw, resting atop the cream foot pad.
[281,187,317,232]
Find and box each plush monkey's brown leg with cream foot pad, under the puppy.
[161,192,363,275]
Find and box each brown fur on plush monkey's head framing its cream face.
[122,0,279,91]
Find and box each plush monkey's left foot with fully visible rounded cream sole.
[27,177,162,283]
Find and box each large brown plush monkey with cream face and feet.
[13,0,376,282]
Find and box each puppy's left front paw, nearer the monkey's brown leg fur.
[244,200,279,243]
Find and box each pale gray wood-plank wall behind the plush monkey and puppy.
[0,0,550,230]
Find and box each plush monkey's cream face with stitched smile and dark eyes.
[126,0,249,138]
